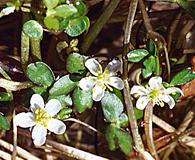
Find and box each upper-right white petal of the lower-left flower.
[45,99,62,116]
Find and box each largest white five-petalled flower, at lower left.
[14,94,66,146]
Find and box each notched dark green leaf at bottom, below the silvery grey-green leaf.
[105,124,132,153]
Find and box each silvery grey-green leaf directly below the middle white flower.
[101,91,124,123]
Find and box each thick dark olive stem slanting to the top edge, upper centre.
[80,0,120,53]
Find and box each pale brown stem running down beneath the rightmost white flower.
[144,102,159,160]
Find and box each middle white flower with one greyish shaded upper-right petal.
[79,58,124,101]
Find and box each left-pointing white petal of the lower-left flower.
[13,112,35,128]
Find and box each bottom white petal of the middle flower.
[92,84,105,102]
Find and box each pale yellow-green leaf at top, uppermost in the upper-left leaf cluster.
[53,4,78,18]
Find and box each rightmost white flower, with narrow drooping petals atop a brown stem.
[131,76,183,110]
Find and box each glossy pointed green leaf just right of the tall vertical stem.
[127,49,149,62]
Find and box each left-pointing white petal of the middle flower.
[79,76,97,90]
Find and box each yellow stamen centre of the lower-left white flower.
[35,108,52,127]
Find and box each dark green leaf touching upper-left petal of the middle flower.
[66,53,86,74]
